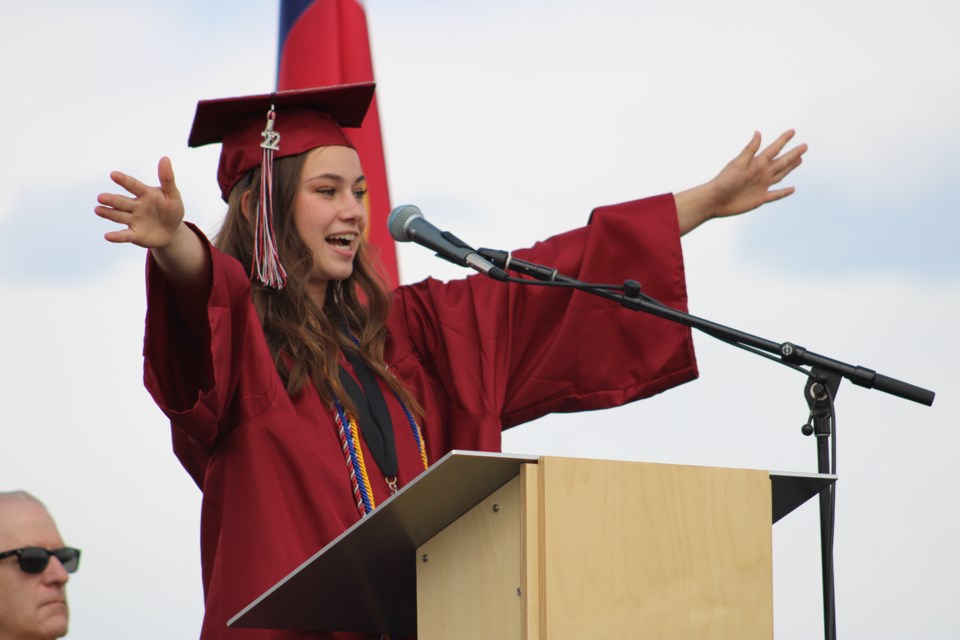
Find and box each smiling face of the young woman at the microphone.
[293,147,367,291]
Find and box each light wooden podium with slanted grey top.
[229,451,835,640]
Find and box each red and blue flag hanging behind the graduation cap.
[277,0,399,288]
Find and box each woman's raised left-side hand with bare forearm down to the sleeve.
[94,157,210,297]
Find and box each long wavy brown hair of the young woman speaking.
[213,153,422,416]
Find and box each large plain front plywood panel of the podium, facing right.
[538,458,773,640]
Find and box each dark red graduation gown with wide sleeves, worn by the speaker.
[144,195,697,640]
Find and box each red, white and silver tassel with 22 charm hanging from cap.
[250,108,287,289]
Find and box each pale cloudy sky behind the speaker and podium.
[0,0,960,640]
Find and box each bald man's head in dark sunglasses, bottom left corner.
[0,491,80,640]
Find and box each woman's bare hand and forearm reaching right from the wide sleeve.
[675,129,807,235]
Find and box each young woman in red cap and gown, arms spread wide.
[95,86,806,640]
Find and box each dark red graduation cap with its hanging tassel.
[187,82,374,289]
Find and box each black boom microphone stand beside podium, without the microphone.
[477,248,935,640]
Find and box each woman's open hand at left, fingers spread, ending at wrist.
[94,157,183,249]
